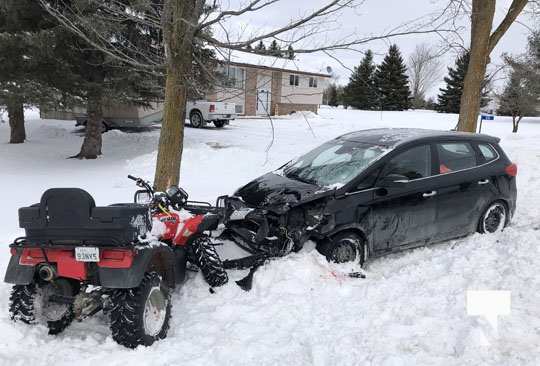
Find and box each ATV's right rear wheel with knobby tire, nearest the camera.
[110,272,171,348]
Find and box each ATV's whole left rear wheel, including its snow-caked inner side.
[9,279,75,334]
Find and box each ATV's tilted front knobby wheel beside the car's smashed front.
[190,235,229,287]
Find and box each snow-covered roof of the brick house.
[217,51,331,78]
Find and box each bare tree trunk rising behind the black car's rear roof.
[458,0,495,132]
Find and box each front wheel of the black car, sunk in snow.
[317,231,365,266]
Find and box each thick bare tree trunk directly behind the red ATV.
[154,0,204,191]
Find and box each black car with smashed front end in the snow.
[221,129,517,263]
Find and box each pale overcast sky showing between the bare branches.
[216,0,540,95]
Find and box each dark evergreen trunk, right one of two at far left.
[74,88,103,159]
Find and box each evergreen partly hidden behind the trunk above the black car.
[436,52,489,113]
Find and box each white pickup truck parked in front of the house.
[186,100,236,128]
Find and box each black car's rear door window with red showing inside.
[437,142,476,174]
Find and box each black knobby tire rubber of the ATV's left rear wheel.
[9,283,74,335]
